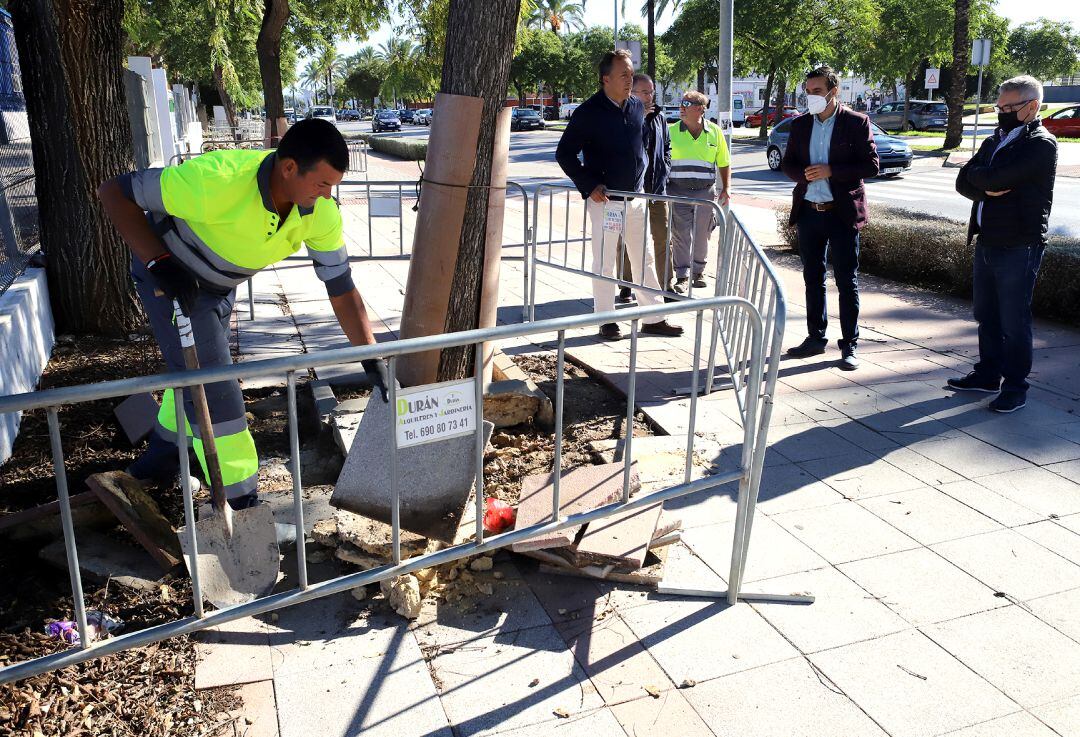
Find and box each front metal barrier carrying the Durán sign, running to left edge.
[0,297,806,683]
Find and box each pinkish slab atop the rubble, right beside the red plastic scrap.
[512,464,640,552]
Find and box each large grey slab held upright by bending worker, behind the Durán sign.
[330,391,494,542]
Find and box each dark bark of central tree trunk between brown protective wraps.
[438,0,521,381]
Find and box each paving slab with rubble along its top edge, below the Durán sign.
[411,573,551,647]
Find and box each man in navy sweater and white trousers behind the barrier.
[555,50,683,340]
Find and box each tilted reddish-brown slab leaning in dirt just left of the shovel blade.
[86,471,181,571]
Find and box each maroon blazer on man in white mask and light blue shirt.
[781,105,879,229]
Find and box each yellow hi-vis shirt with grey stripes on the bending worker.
[121,150,352,295]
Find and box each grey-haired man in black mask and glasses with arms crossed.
[948,76,1057,413]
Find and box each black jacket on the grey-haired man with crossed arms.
[956,118,1057,249]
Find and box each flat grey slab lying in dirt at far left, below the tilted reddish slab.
[38,530,161,591]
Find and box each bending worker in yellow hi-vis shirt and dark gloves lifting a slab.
[98,119,387,509]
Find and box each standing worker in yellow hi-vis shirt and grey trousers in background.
[667,90,731,294]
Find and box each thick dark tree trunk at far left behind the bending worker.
[9,0,141,335]
